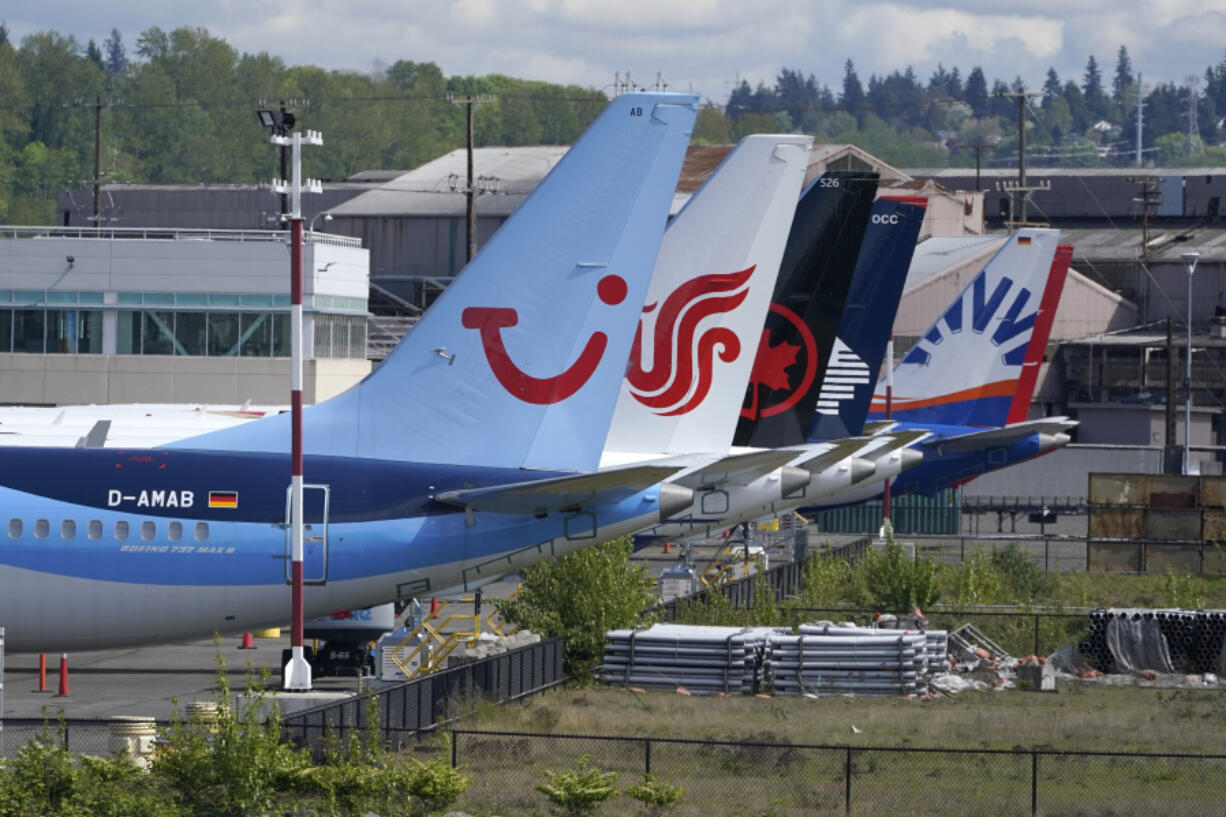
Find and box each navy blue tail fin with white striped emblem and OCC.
[809,196,928,439]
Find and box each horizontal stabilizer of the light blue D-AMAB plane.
[434,465,682,515]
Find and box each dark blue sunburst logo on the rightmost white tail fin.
[902,270,1038,366]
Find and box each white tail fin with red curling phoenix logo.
[604,134,813,454]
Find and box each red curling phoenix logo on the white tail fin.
[625,266,755,417]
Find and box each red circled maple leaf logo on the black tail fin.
[741,303,818,420]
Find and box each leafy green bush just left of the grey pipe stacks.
[497,537,655,678]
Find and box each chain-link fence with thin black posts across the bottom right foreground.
[451,726,1226,817]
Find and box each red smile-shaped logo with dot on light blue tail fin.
[460,275,628,405]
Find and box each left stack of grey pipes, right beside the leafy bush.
[600,624,772,694]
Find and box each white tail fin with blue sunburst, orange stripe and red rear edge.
[870,228,1072,427]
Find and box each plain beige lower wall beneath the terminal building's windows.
[0,355,370,405]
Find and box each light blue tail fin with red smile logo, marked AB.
[178,93,698,470]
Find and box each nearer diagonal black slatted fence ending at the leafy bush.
[282,638,565,750]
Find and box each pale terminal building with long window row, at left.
[0,227,370,405]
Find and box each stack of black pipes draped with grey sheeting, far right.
[1078,607,1226,673]
